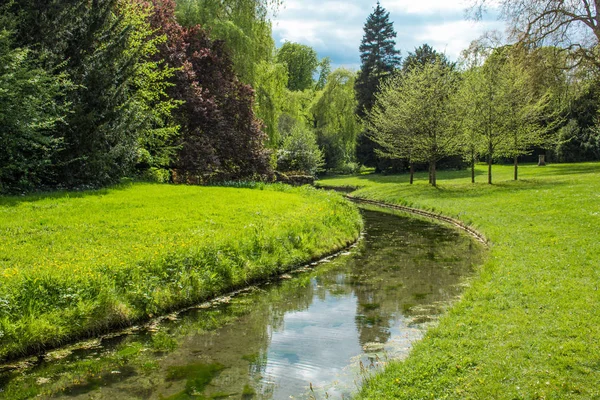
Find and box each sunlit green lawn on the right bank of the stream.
[320,163,600,399]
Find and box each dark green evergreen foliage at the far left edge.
[0,27,71,192]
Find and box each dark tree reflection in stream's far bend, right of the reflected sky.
[350,211,481,346]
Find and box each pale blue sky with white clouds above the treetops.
[272,0,504,70]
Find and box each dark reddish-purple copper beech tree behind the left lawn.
[151,0,271,183]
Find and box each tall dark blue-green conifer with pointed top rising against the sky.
[355,2,401,166]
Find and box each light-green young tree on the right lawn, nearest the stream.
[369,63,461,186]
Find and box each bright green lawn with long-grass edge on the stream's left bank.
[0,183,362,361]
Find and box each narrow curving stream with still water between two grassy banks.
[0,209,483,400]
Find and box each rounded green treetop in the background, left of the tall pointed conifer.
[277,42,319,91]
